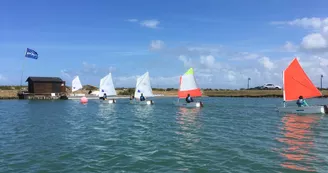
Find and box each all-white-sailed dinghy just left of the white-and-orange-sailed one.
[130,72,154,105]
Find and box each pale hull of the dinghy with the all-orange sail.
[278,106,325,114]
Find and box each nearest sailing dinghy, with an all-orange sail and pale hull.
[278,58,328,114]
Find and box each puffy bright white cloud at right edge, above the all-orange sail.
[301,33,327,50]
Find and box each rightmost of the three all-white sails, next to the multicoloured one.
[134,72,154,99]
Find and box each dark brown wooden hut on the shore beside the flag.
[26,77,66,94]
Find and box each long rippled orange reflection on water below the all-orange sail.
[278,114,320,171]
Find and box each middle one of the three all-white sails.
[99,73,116,97]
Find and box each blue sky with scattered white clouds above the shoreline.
[0,0,328,89]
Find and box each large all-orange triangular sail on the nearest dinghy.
[283,58,322,101]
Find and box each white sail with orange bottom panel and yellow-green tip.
[178,68,202,98]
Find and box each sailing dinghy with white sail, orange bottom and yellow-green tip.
[174,68,203,108]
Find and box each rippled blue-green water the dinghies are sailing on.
[0,98,328,173]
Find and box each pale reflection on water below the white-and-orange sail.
[176,107,201,147]
